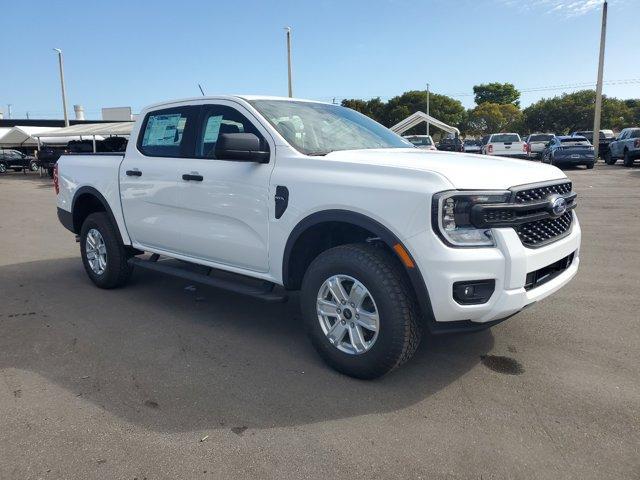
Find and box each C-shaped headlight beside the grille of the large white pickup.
[431,191,511,247]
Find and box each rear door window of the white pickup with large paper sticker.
[138,107,198,157]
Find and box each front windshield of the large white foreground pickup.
[250,100,413,155]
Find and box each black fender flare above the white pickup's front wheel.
[282,210,435,326]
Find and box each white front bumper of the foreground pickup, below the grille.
[406,213,581,330]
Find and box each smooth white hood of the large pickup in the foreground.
[325,148,567,190]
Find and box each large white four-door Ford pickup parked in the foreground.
[54,96,580,378]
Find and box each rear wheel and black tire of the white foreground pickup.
[80,212,133,289]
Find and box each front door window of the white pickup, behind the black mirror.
[196,105,264,158]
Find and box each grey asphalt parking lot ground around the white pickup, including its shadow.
[0,164,640,480]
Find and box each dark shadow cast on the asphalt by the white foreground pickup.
[0,258,493,433]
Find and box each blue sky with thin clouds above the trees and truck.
[0,0,640,119]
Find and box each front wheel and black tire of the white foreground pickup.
[301,244,422,379]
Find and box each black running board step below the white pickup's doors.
[129,257,288,303]
